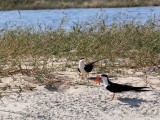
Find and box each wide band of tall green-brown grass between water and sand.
[0,15,160,75]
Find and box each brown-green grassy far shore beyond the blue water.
[0,0,160,10]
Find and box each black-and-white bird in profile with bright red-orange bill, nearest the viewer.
[95,74,151,100]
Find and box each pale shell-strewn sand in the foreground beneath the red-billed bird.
[0,73,160,120]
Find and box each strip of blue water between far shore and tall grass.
[0,7,160,29]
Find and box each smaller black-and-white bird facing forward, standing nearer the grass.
[78,58,102,78]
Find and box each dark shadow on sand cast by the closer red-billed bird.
[118,98,147,107]
